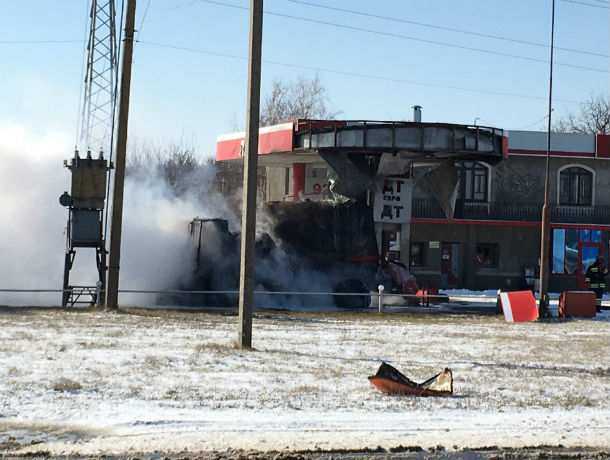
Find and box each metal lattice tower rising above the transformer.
[79,0,118,152]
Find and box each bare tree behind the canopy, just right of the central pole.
[260,76,338,126]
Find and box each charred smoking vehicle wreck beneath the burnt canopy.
[178,202,379,308]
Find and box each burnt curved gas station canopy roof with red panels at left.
[216,119,508,166]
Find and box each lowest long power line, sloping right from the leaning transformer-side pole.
[139,41,579,104]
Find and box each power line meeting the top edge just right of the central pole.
[286,0,610,58]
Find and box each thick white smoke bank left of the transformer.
[0,123,70,305]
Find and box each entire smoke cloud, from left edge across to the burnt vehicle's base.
[0,122,367,308]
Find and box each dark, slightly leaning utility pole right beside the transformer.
[106,0,136,310]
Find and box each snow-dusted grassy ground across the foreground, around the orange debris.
[0,310,610,455]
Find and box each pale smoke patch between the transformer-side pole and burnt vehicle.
[121,165,234,305]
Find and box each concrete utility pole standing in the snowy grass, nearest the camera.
[238,0,263,348]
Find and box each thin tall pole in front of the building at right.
[539,0,555,318]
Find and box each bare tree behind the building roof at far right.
[554,95,610,134]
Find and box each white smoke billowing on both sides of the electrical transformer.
[0,123,229,305]
